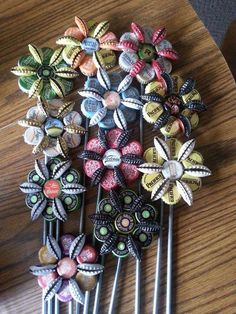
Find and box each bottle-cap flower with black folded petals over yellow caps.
[142,73,206,137]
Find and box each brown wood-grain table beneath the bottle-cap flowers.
[0,0,236,314]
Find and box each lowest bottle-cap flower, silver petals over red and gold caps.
[30,234,104,304]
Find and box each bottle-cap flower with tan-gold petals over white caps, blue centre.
[18,97,85,157]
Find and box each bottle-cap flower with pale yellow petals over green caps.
[11,45,78,99]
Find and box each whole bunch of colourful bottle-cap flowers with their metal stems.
[11,17,211,314]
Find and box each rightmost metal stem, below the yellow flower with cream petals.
[166,205,173,314]
